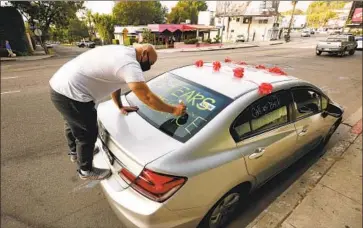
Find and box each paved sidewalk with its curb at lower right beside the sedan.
[247,108,362,228]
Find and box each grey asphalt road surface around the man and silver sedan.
[1,37,362,228]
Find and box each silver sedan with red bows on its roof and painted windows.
[94,63,343,228]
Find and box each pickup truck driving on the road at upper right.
[315,34,358,57]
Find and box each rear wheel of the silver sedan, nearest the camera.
[198,185,248,228]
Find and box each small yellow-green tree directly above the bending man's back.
[93,13,115,44]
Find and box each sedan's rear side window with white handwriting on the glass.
[231,91,292,141]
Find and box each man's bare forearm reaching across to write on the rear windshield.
[128,82,185,116]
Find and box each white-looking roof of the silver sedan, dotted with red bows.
[170,62,298,99]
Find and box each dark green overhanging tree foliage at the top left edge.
[10,1,83,36]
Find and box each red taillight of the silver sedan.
[119,168,187,202]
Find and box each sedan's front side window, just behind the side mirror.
[292,89,321,119]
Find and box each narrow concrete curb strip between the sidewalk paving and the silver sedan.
[246,108,362,228]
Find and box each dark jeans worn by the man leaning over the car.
[50,89,98,171]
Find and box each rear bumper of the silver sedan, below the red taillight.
[93,139,199,228]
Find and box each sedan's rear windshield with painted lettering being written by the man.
[126,73,232,142]
